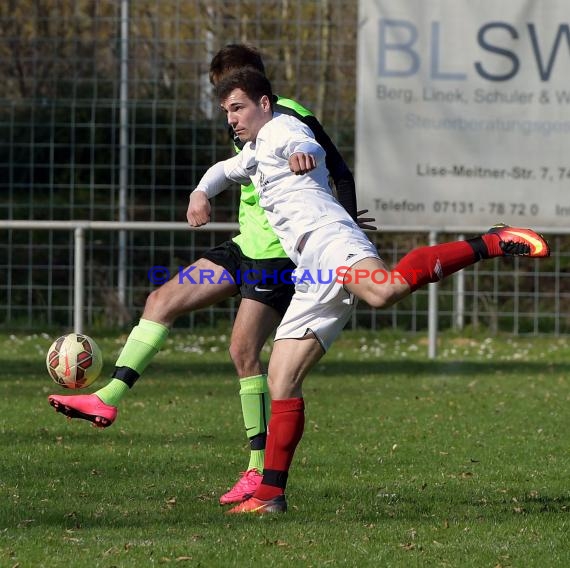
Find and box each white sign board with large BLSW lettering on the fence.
[356,0,570,228]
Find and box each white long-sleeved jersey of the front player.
[196,114,356,263]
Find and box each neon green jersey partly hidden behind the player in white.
[229,97,313,260]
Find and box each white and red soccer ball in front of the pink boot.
[46,333,103,389]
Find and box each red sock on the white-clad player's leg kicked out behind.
[394,241,474,292]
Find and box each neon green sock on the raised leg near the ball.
[95,319,169,406]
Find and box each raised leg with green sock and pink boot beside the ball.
[48,259,237,428]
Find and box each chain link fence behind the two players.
[0,0,570,333]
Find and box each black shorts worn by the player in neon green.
[202,241,295,314]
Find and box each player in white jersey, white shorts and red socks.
[187,69,549,514]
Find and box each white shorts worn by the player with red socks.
[275,222,380,351]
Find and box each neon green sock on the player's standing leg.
[239,375,271,472]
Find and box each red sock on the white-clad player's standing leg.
[254,398,305,500]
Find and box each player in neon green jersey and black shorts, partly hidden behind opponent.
[48,44,370,504]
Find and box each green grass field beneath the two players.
[0,331,570,568]
